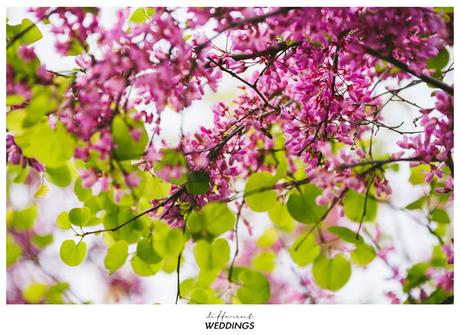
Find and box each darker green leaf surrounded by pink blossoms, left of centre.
[112,115,148,160]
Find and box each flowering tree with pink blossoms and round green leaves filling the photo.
[6,7,454,303]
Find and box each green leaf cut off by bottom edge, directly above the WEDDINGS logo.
[235,269,270,304]
